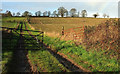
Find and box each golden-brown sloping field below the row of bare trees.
[30,18,108,33]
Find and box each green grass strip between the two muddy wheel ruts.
[24,24,69,72]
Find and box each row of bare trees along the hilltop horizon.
[2,7,109,18]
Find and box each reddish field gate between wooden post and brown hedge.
[62,25,85,43]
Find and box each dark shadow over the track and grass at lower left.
[2,31,30,73]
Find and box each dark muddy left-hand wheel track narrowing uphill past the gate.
[8,23,31,72]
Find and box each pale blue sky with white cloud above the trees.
[2,0,118,18]
